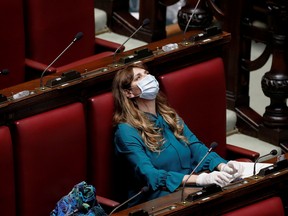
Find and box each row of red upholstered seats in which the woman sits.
[0,58,259,216]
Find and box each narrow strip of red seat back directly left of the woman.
[88,92,126,201]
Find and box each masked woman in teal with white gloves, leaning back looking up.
[112,64,243,207]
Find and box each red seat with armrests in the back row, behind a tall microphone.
[24,0,120,78]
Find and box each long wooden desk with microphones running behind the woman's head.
[0,31,231,125]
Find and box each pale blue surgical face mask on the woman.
[137,74,159,100]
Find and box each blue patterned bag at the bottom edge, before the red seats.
[50,181,107,216]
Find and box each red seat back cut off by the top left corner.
[0,0,25,88]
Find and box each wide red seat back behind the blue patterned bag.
[15,103,87,216]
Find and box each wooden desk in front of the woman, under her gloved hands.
[113,154,288,216]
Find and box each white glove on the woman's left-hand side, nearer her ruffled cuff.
[196,171,233,187]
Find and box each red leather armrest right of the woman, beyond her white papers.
[226,144,260,161]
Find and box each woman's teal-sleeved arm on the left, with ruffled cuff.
[115,124,184,192]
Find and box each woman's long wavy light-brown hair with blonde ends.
[112,64,188,152]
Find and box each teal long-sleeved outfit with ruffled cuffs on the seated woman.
[115,113,227,206]
